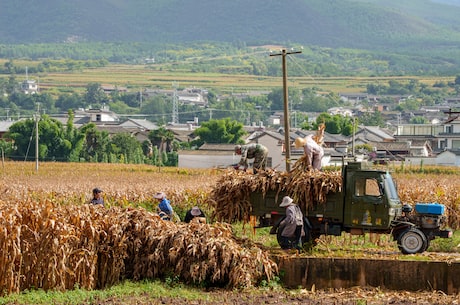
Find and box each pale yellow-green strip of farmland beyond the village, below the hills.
[0,59,454,93]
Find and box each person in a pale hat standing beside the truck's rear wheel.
[279,196,305,249]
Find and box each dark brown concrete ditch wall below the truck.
[274,256,460,294]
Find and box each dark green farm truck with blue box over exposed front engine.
[250,162,452,254]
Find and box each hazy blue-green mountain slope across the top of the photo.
[0,0,460,50]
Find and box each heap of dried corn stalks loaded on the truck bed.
[208,156,342,223]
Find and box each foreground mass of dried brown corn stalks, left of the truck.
[0,200,277,293]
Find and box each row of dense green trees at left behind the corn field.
[0,111,178,166]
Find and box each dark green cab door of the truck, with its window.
[345,172,389,229]
